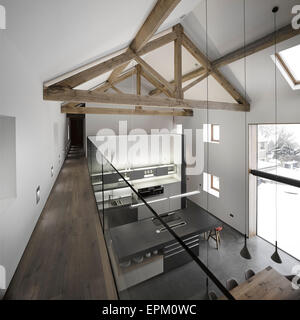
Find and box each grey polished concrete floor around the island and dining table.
[120,226,300,300]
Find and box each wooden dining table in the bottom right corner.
[221,267,300,300]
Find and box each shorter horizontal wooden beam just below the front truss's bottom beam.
[61,106,193,117]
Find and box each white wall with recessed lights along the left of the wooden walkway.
[0,1,66,298]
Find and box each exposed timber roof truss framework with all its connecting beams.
[44,0,300,116]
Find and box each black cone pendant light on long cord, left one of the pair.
[240,0,252,260]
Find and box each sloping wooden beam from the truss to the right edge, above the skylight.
[212,24,300,68]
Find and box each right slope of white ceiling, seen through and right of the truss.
[82,0,297,102]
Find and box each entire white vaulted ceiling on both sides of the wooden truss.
[7,0,299,102]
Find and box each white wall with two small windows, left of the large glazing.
[176,36,300,233]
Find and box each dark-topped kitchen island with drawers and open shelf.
[107,201,222,291]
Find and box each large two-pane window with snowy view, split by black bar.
[257,124,300,259]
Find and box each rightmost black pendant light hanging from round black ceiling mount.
[271,6,282,263]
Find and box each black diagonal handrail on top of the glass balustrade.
[98,145,235,300]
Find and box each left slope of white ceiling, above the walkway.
[1,0,201,81]
